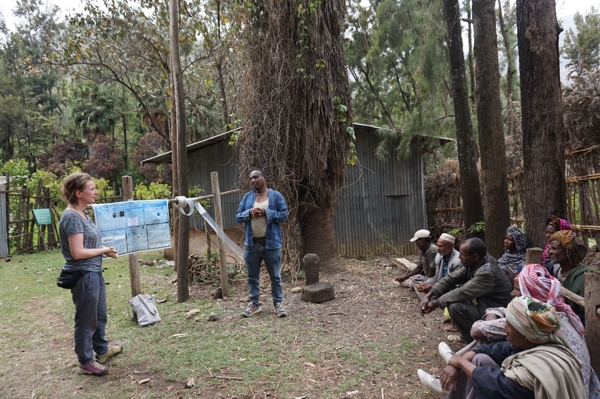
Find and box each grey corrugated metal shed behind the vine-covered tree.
[142,124,449,256]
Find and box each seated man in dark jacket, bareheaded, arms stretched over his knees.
[420,238,512,343]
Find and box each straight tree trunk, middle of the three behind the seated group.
[473,0,510,258]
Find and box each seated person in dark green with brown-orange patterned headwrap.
[548,230,595,326]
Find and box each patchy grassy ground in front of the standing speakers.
[0,251,437,399]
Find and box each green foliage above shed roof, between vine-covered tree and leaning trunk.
[345,0,453,140]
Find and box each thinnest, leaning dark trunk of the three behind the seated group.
[444,0,484,237]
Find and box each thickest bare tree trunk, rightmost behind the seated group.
[517,0,566,247]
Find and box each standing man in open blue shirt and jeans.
[235,169,288,317]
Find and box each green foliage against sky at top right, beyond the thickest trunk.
[562,7,600,72]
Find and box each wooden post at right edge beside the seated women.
[584,272,600,375]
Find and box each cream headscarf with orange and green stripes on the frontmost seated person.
[506,296,568,346]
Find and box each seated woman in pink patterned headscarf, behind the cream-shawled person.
[471,264,600,399]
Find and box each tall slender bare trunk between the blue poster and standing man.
[169,0,190,302]
